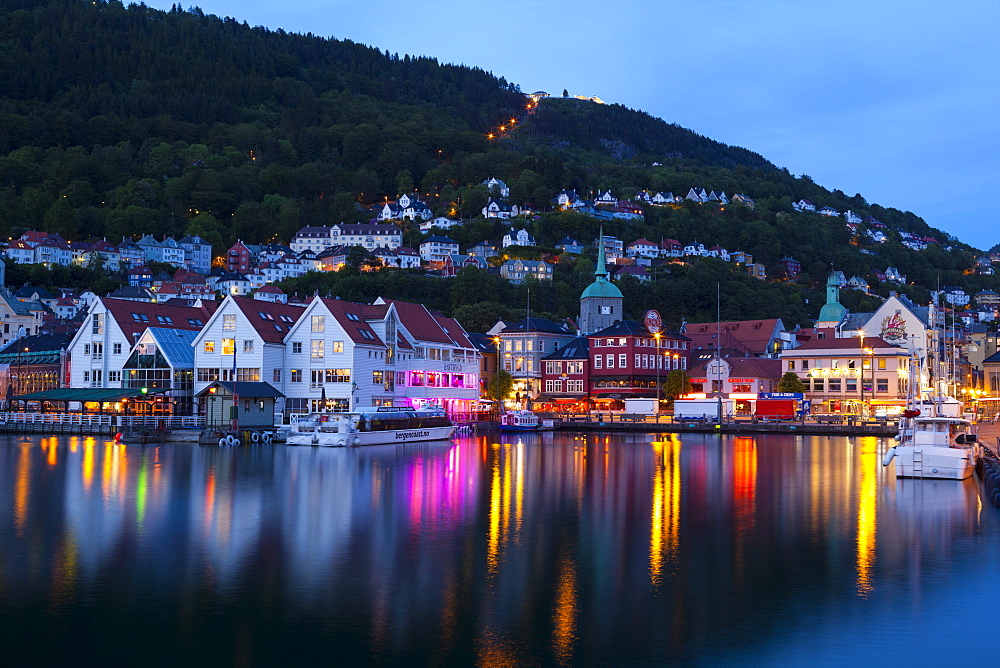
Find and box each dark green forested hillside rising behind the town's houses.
[0,0,997,332]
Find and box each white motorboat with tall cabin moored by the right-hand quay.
[882,411,979,480]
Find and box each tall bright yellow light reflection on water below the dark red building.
[649,434,681,587]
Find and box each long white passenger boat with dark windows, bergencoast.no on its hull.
[285,406,457,446]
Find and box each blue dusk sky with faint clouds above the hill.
[146,0,1000,249]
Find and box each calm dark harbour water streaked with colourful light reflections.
[0,433,1000,665]
